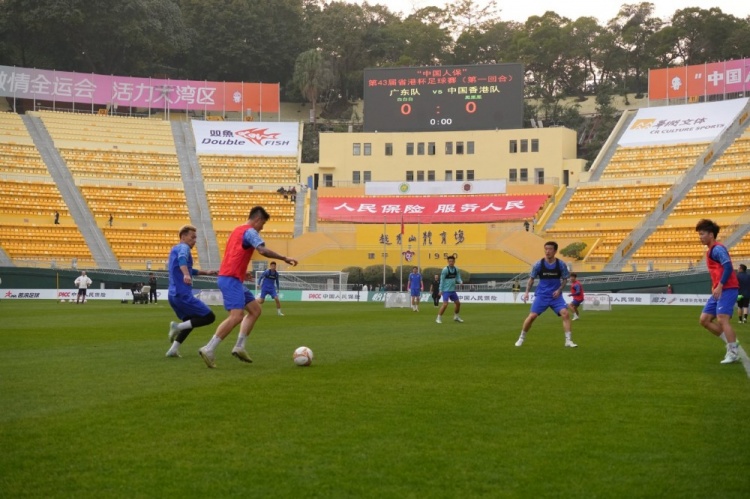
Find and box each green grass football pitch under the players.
[0,300,750,498]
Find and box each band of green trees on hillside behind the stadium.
[0,0,750,104]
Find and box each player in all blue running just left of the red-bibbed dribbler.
[166,225,218,357]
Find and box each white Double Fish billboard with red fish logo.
[192,120,300,156]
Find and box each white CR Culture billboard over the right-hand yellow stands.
[617,98,748,147]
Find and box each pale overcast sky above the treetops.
[346,0,750,24]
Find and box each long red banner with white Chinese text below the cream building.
[318,194,549,223]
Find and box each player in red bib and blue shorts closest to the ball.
[198,206,297,368]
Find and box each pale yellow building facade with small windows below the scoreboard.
[300,127,585,187]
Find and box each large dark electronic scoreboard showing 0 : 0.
[364,63,523,132]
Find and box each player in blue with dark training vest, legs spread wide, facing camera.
[516,241,578,348]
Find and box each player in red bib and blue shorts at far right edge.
[695,218,739,364]
